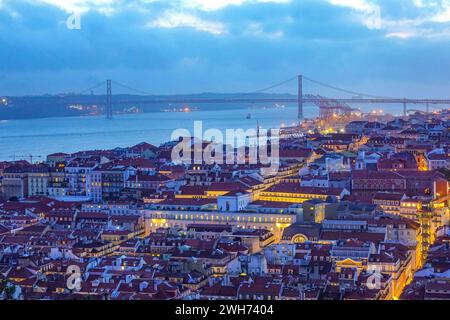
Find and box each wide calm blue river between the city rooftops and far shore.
[0,107,317,161]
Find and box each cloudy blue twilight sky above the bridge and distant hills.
[0,0,450,97]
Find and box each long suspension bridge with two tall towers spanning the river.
[74,75,450,123]
